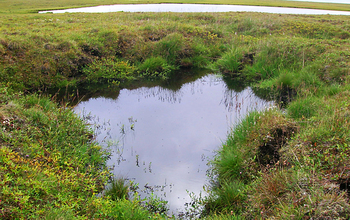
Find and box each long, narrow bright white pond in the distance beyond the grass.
[39,4,350,15]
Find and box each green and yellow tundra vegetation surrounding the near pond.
[0,1,350,219]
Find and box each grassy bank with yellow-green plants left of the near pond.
[0,87,169,219]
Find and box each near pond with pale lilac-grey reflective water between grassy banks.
[75,74,273,213]
